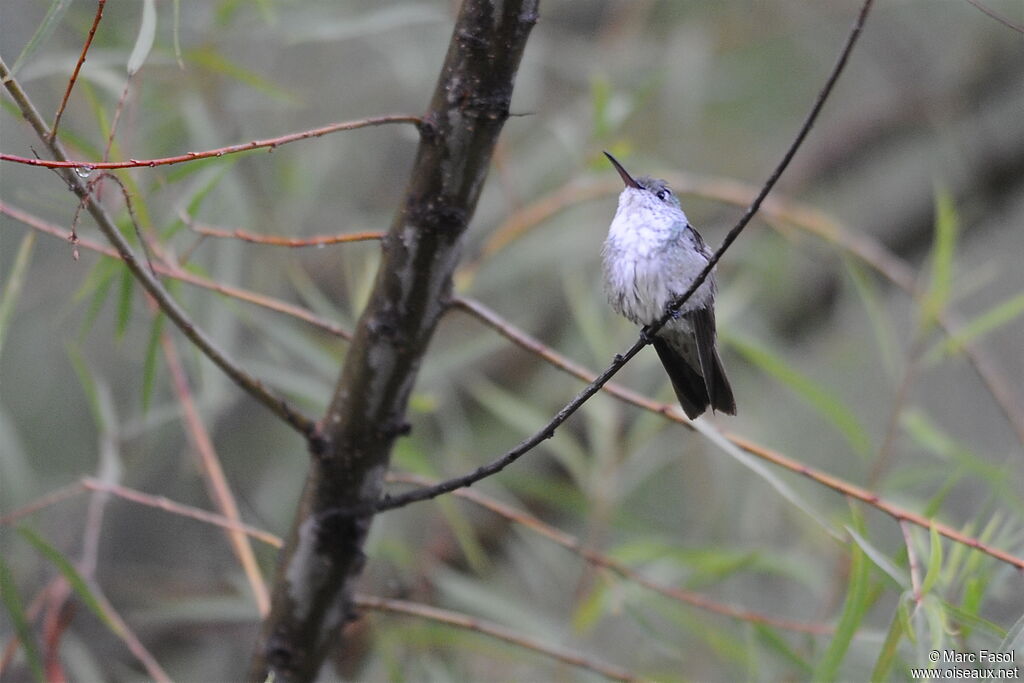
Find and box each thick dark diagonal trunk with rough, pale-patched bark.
[250,0,539,681]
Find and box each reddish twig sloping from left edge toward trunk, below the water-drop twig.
[0,202,352,339]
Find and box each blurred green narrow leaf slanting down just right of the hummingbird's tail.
[721,334,873,458]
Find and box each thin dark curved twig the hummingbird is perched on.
[372,0,873,515]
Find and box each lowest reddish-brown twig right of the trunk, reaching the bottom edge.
[353,595,641,681]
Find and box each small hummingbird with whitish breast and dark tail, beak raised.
[601,152,736,420]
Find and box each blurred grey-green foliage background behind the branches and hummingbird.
[0,0,1024,681]
